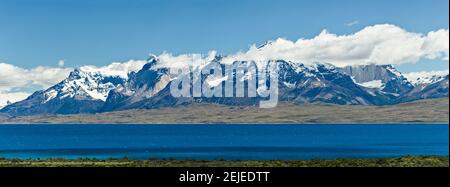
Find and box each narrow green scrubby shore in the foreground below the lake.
[0,156,449,167]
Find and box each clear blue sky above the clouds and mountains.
[0,0,449,71]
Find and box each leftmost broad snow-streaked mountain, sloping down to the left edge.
[2,66,134,115]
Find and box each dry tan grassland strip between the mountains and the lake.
[0,98,449,124]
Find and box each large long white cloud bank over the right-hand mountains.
[221,24,449,66]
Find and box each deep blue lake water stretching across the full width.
[0,124,449,160]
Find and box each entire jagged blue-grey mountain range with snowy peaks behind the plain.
[0,56,449,116]
